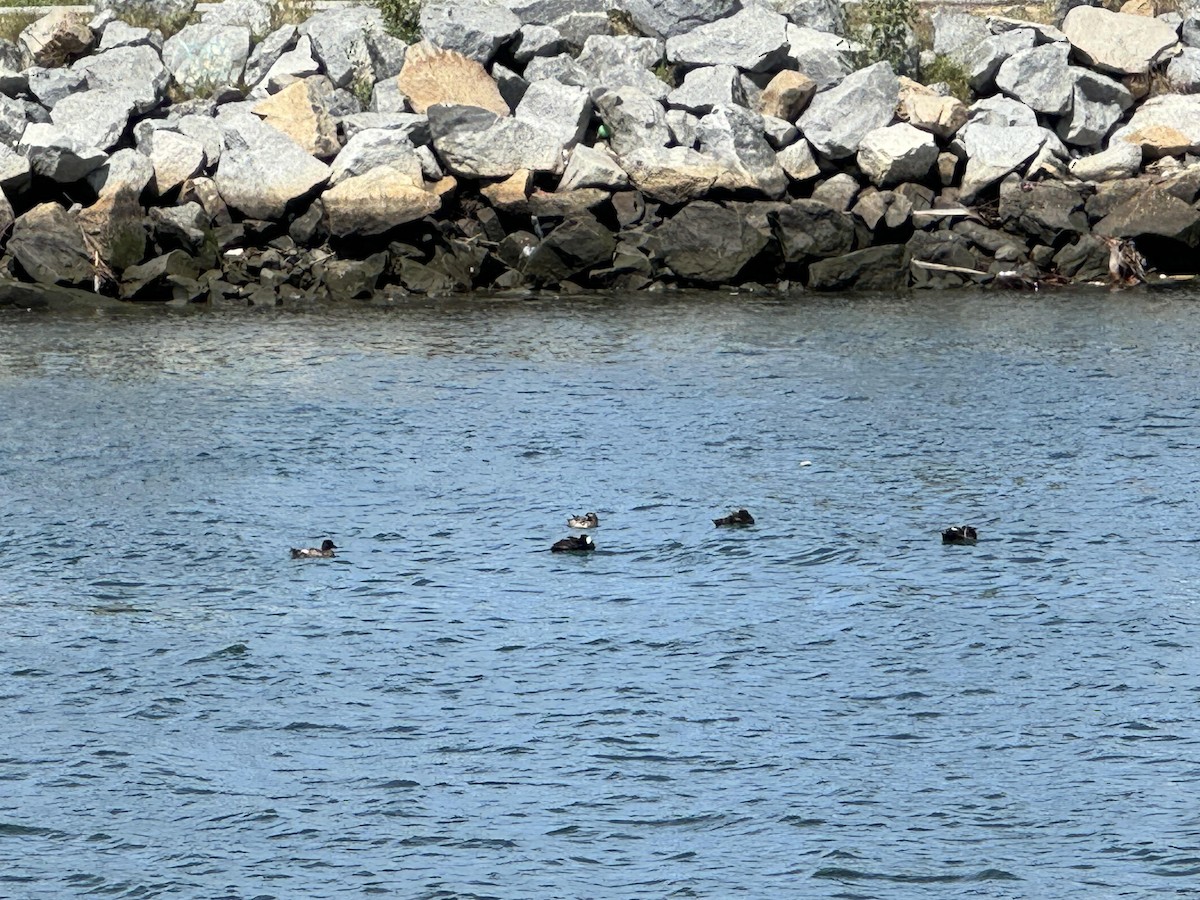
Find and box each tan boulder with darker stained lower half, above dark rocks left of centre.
[322,166,442,238]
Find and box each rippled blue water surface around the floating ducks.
[0,293,1200,900]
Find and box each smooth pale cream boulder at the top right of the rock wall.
[1062,6,1178,74]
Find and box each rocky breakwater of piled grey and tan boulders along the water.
[0,0,1200,305]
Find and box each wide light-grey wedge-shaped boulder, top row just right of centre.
[667,6,791,72]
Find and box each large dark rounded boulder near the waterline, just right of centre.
[658,200,769,284]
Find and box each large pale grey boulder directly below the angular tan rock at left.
[214,113,329,220]
